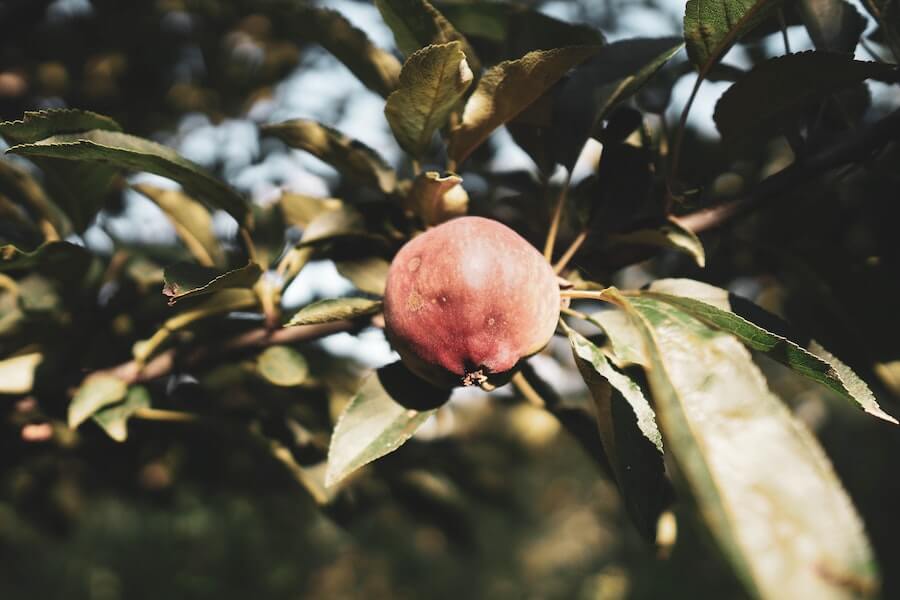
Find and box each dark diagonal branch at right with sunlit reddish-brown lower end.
[676,109,900,233]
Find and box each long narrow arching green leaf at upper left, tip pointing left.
[7,129,249,225]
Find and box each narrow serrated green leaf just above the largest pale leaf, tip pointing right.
[642,279,897,424]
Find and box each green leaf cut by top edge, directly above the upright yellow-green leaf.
[375,0,481,73]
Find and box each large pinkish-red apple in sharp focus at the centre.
[384,217,560,388]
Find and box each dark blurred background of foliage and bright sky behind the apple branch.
[0,0,900,600]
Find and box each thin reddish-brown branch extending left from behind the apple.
[102,321,360,385]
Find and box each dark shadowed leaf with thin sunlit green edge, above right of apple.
[553,38,684,169]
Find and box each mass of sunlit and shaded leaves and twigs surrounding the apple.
[0,0,898,598]
